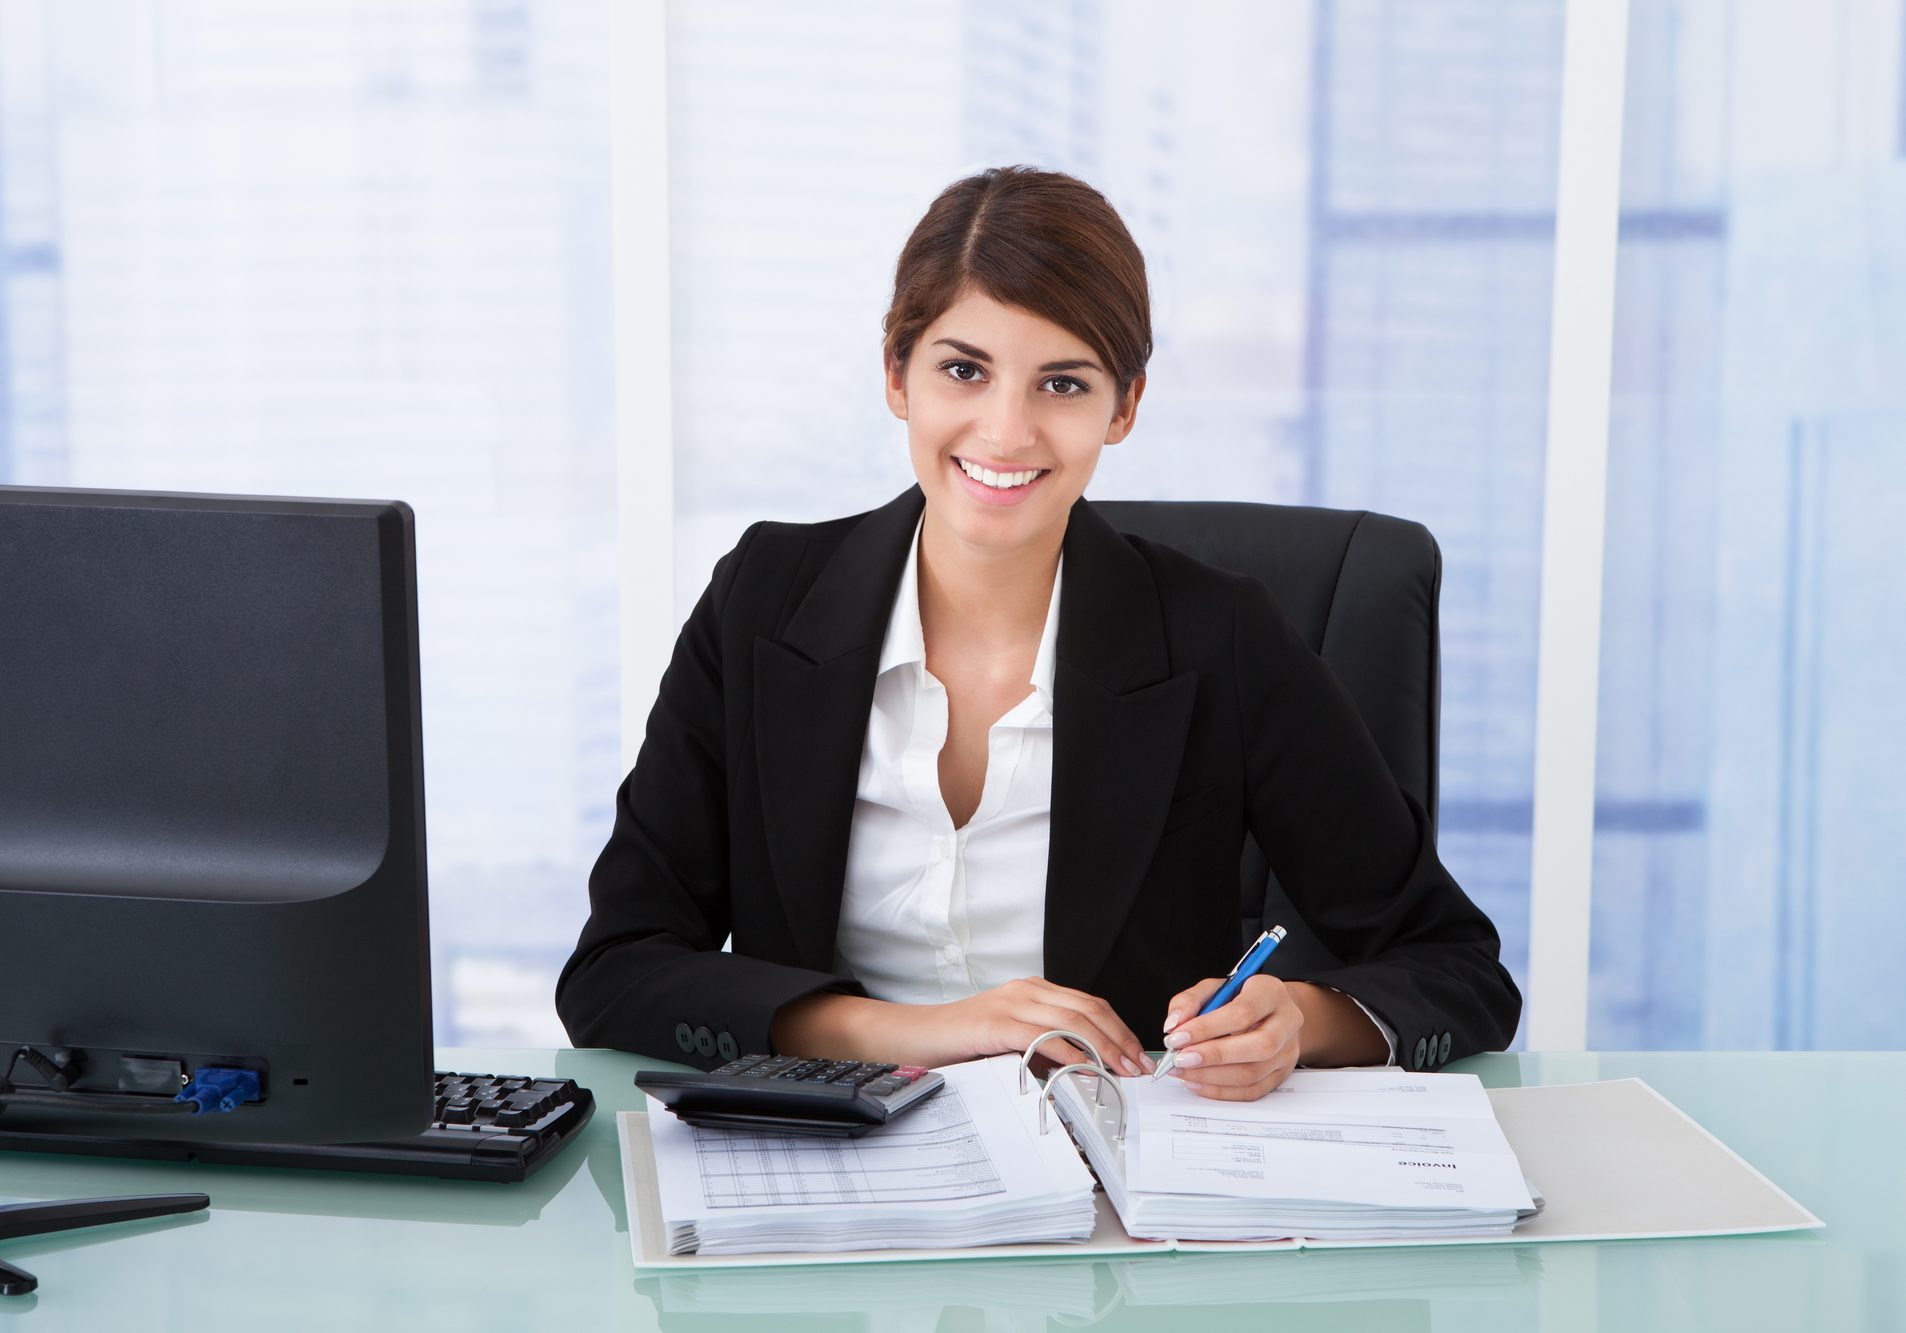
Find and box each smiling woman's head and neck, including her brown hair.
[882,168,1151,568]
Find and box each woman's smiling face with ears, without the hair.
[886,292,1146,551]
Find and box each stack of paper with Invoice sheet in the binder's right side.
[1058,1070,1536,1240]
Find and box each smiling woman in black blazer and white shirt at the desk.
[557,168,1521,1100]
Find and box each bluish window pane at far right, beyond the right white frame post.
[1590,0,1906,1049]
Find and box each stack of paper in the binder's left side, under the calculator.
[648,1056,1094,1255]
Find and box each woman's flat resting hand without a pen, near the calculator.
[881,976,1153,1077]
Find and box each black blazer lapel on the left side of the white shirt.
[755,486,924,971]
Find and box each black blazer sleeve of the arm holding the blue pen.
[1233,580,1523,1068]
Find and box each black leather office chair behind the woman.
[1092,500,1443,976]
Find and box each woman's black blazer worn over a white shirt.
[557,486,1521,1068]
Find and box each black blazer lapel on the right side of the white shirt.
[1044,500,1197,988]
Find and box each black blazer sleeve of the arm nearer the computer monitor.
[557,523,865,1068]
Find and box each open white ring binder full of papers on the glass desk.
[618,1060,1820,1282]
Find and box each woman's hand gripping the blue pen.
[1165,973,1304,1102]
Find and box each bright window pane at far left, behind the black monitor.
[0,0,619,1043]
